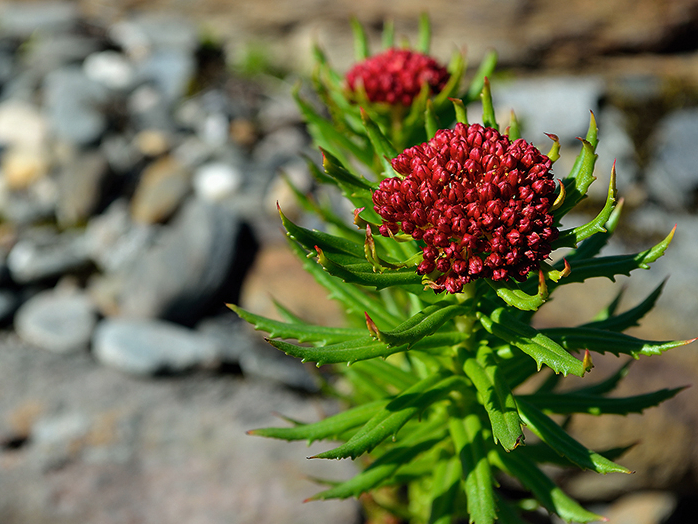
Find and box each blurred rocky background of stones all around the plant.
[0,0,698,524]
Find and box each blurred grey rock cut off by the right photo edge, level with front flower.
[646,108,698,210]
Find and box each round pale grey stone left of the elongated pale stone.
[15,290,97,353]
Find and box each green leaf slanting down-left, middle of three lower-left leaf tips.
[312,371,464,459]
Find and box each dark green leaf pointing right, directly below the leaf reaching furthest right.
[516,388,684,415]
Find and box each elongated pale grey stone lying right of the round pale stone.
[92,318,218,375]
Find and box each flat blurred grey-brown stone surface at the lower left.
[0,332,360,524]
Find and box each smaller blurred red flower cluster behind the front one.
[347,49,450,106]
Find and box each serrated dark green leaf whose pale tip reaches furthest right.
[541,327,695,358]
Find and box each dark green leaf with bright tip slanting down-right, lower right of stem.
[517,397,632,474]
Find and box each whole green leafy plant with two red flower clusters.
[231,19,690,524]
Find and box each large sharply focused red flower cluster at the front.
[373,124,558,293]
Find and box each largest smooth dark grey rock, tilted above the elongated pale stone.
[120,199,247,323]
